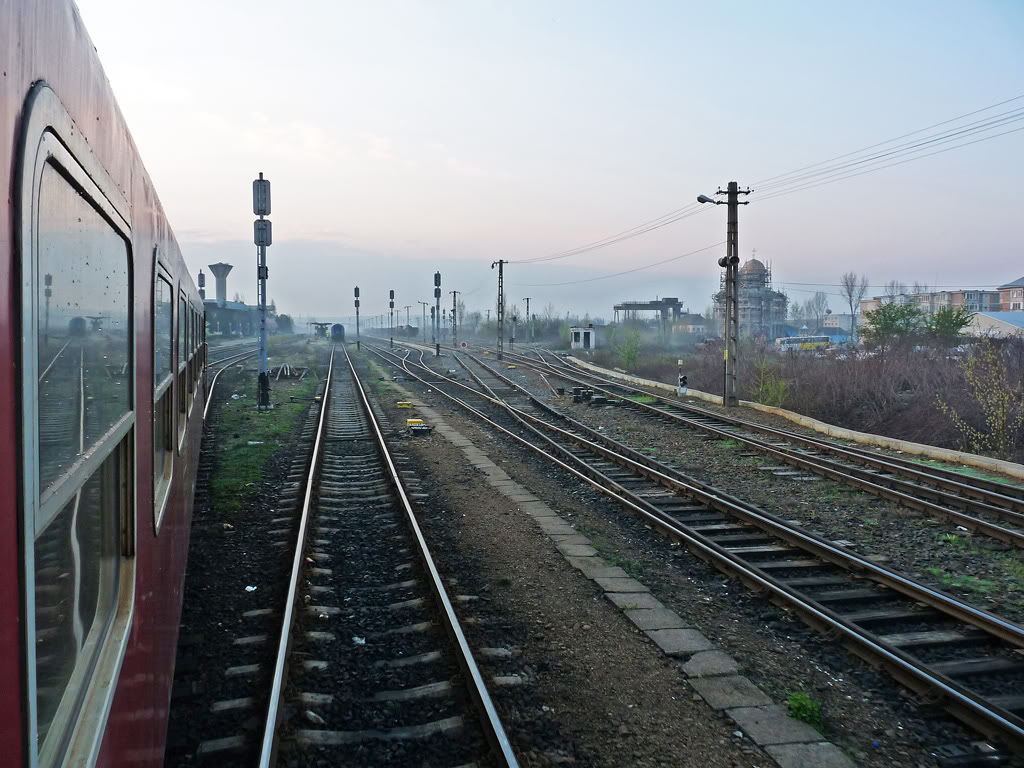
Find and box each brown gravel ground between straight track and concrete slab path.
[364,366,771,768]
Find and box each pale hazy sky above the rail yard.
[79,0,1024,317]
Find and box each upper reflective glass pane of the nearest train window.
[37,164,132,496]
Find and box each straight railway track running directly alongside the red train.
[251,348,516,766]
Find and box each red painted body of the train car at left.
[0,0,205,766]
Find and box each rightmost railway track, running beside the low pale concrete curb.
[483,350,1024,548]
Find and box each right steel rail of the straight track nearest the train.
[344,349,518,768]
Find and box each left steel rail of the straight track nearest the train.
[253,347,334,768]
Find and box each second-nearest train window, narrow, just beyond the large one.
[153,274,174,531]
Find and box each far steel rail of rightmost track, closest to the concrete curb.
[528,350,1024,512]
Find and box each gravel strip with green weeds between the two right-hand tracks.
[489,358,1024,624]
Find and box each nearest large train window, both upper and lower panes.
[23,156,134,765]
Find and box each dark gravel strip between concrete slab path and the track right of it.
[382,350,1024,766]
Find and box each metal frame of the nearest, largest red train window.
[14,82,138,768]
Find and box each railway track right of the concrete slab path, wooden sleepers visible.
[373,348,1024,750]
